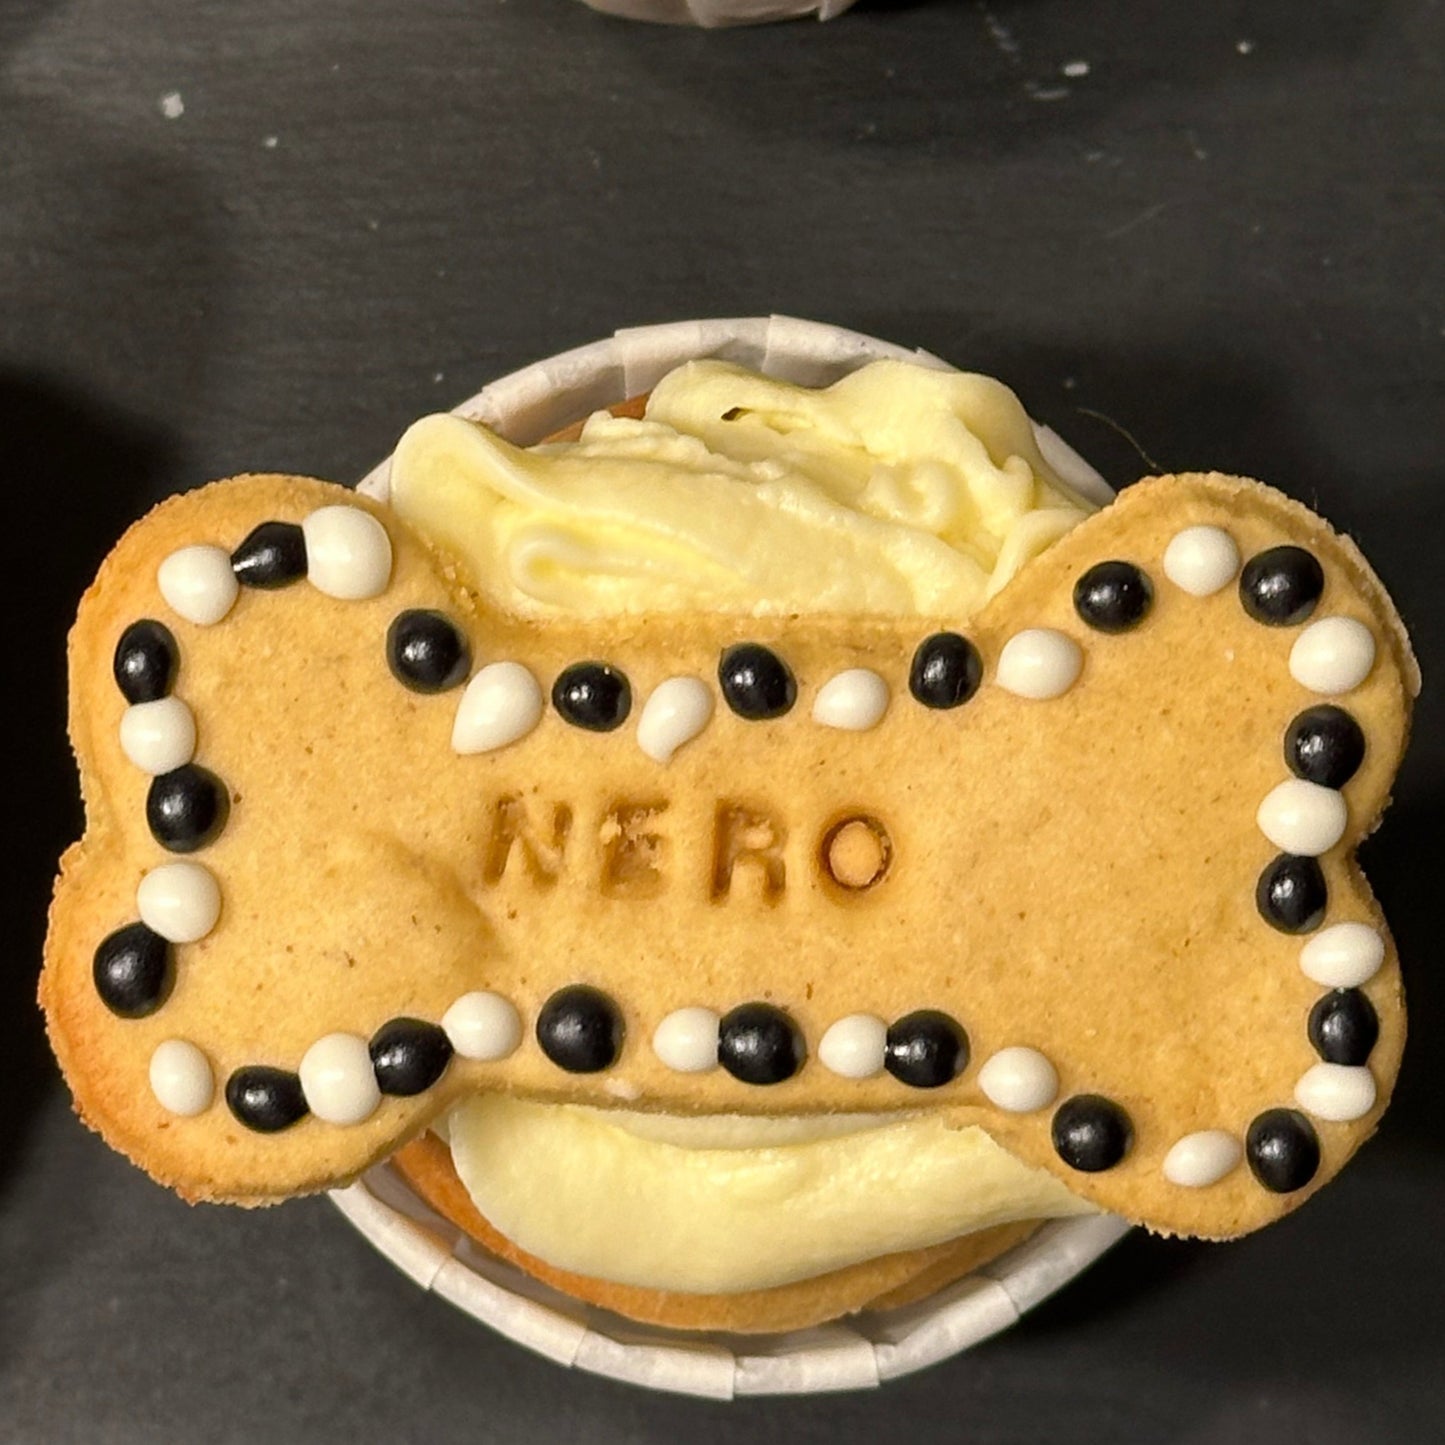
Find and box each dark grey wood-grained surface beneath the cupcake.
[0,0,1445,1445]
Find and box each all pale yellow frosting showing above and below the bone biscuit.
[390,361,1094,1293]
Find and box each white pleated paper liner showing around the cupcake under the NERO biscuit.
[341,313,1129,1399]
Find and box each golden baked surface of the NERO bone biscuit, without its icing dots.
[42,475,1418,1237]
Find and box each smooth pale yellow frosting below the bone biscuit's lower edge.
[448,1095,1092,1293]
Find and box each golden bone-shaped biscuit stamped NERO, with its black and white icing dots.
[40,475,1418,1237]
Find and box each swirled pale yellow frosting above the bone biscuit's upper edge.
[390,361,1092,621]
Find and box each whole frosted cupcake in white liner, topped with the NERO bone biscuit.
[42,321,1416,1393]
